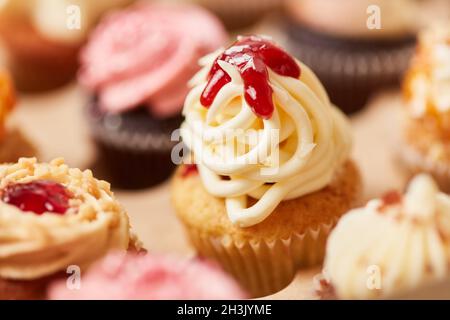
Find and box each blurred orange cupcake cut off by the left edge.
[0,68,36,163]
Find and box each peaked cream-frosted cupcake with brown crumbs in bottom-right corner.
[318,174,450,299]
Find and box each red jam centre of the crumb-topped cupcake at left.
[1,180,72,214]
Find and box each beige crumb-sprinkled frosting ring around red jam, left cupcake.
[0,158,130,280]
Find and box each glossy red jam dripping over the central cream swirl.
[200,36,300,119]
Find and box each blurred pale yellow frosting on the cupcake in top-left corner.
[0,0,131,43]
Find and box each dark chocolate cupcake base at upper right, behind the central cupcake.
[286,22,415,114]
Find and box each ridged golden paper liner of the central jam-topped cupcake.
[187,220,337,297]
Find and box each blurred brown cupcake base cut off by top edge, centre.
[188,0,283,29]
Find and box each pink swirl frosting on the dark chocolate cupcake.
[79,4,227,118]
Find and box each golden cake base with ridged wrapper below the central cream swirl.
[172,160,362,297]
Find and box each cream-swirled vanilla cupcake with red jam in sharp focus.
[172,36,361,297]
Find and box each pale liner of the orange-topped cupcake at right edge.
[398,143,450,193]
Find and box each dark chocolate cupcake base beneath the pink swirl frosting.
[87,104,181,189]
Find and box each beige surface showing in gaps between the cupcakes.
[10,84,404,299]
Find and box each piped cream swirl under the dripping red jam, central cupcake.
[181,38,351,227]
